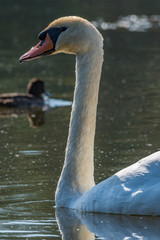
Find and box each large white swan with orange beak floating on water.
[20,16,160,215]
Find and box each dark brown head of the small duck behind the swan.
[26,78,48,98]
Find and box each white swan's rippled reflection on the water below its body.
[56,208,160,240]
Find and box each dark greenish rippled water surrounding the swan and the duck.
[0,0,160,240]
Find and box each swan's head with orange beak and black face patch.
[20,16,103,62]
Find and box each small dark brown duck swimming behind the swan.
[0,78,48,108]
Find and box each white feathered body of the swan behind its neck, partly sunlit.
[75,152,160,215]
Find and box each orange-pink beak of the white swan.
[19,33,54,63]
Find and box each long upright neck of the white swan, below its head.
[56,47,103,206]
